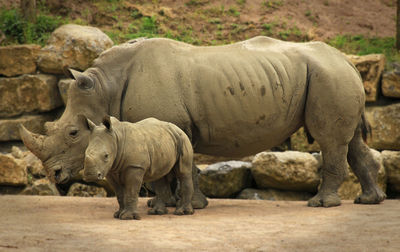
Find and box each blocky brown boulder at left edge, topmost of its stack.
[0,45,41,77]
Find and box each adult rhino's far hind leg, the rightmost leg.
[347,124,386,204]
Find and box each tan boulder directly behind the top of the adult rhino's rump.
[347,54,385,102]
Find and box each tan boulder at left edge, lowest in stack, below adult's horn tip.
[0,153,28,186]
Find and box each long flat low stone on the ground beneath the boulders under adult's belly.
[237,188,313,201]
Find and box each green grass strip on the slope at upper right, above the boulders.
[328,35,400,67]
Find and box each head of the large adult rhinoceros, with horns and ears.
[20,69,108,184]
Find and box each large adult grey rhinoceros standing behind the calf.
[21,37,385,207]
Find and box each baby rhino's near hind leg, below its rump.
[174,156,194,215]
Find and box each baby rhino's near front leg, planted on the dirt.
[119,167,144,220]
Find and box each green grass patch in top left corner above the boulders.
[0,9,63,45]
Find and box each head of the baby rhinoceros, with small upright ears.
[83,117,117,182]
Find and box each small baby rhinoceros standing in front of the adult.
[83,117,193,220]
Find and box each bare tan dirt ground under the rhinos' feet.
[0,196,400,251]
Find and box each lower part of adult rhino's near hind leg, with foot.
[308,144,348,207]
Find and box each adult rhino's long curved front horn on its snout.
[19,124,49,161]
